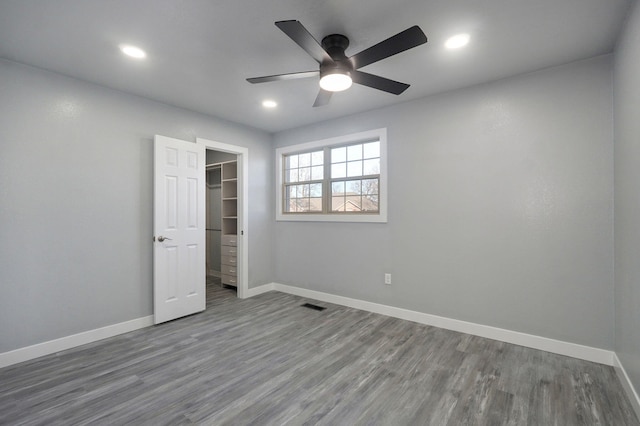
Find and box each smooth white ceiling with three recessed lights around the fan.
[0,0,632,132]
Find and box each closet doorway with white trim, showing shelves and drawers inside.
[197,138,248,298]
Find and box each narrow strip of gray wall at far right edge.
[614,2,640,390]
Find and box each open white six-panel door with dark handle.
[153,135,206,324]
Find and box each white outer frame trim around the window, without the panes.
[276,128,388,223]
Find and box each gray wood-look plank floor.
[0,280,640,426]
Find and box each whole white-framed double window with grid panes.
[276,129,386,222]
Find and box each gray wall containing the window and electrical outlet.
[274,56,616,349]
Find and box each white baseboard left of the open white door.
[0,315,153,368]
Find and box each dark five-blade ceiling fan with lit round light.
[247,20,427,107]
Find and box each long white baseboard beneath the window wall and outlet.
[271,283,615,365]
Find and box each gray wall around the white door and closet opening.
[0,60,274,352]
